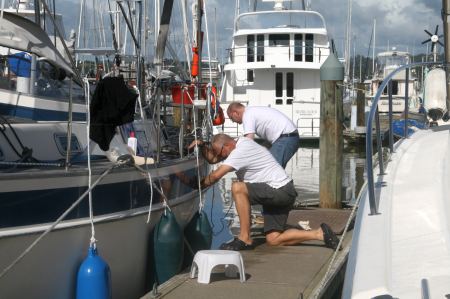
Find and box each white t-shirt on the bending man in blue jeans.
[242,106,297,143]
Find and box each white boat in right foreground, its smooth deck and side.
[342,59,450,299]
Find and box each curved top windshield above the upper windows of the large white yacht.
[236,11,325,31]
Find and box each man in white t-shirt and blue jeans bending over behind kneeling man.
[227,102,300,168]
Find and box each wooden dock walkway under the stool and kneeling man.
[142,208,352,299]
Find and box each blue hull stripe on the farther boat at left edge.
[0,103,86,121]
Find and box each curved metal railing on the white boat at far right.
[366,62,443,215]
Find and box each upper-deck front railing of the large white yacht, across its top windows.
[228,45,330,63]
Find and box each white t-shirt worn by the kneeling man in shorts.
[223,137,291,189]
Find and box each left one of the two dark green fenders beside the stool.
[153,209,184,284]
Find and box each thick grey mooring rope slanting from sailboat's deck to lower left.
[0,161,119,279]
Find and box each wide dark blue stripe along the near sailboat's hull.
[0,170,195,228]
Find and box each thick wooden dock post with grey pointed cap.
[319,53,344,209]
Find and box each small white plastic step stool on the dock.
[191,250,245,283]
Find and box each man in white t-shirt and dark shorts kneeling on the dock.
[189,134,339,250]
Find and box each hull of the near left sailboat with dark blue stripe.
[0,159,207,298]
